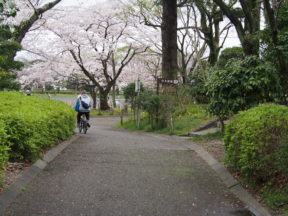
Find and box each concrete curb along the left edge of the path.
[0,135,80,215]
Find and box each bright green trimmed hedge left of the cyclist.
[0,92,75,168]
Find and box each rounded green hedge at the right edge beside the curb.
[224,104,288,184]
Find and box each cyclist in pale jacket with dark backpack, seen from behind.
[76,90,92,127]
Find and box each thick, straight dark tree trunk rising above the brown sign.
[161,0,178,79]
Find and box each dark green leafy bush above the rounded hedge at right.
[207,56,281,118]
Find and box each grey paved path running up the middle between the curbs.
[4,118,268,216]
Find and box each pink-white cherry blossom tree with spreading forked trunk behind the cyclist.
[22,3,147,110]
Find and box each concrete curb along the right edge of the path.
[180,138,272,216]
